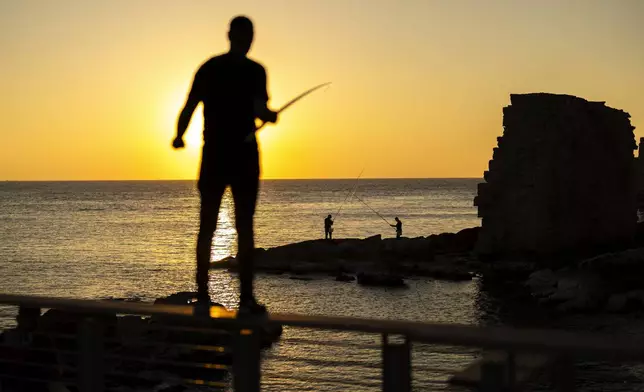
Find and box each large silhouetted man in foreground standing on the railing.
[172,16,277,312]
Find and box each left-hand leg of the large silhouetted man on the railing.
[197,180,226,300]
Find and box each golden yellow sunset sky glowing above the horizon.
[0,0,644,180]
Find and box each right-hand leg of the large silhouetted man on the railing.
[231,171,259,304]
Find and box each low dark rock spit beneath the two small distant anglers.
[211,227,479,281]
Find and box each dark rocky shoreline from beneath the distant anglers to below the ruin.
[211,226,644,313]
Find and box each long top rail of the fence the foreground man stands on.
[6,294,644,359]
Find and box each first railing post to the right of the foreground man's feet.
[382,334,411,392]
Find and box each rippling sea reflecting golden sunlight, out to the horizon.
[0,179,644,392]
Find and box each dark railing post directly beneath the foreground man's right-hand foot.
[233,329,261,392]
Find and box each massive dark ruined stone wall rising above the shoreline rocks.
[474,93,637,255]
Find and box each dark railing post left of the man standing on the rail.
[78,317,105,392]
